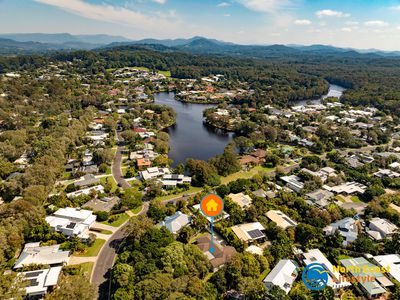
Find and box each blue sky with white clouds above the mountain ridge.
[0,0,400,50]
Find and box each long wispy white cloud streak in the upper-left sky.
[34,0,181,34]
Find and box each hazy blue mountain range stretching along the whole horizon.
[0,33,400,58]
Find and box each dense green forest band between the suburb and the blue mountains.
[0,46,400,114]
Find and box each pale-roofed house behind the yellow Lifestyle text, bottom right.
[340,257,393,298]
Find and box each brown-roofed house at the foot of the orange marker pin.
[196,234,236,271]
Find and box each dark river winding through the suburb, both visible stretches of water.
[154,85,345,167]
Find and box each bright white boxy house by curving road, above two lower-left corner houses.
[46,207,96,239]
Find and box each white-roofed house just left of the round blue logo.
[264,259,299,294]
